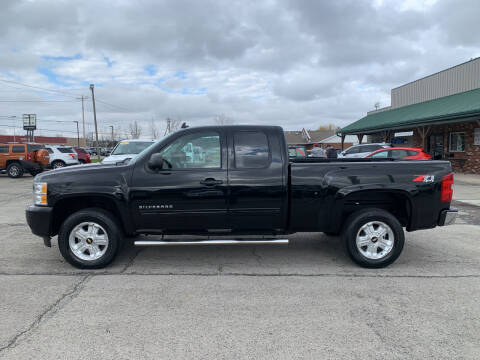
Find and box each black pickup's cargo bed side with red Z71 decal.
[289,158,451,232]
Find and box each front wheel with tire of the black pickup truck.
[58,208,123,269]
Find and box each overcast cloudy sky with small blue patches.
[0,0,480,136]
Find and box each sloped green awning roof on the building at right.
[338,89,480,135]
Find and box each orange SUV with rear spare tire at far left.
[0,143,50,178]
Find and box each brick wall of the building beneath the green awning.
[413,121,480,174]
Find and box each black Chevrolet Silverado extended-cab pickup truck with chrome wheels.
[26,126,457,268]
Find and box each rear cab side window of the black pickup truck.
[233,131,270,169]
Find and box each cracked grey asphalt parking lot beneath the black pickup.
[0,175,480,359]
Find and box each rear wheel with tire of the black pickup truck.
[342,209,405,268]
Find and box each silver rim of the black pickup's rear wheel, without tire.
[356,221,395,260]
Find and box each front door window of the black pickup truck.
[161,131,222,170]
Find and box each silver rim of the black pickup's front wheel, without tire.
[68,221,108,261]
